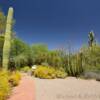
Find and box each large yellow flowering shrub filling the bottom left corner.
[0,71,11,100]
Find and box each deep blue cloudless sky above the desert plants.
[0,0,100,49]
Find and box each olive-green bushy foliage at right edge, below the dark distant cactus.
[82,45,100,72]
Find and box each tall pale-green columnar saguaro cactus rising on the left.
[2,7,13,69]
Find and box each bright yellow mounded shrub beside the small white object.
[34,66,56,79]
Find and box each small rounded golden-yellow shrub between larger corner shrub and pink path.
[9,71,21,86]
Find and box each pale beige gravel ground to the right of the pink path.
[34,77,100,100]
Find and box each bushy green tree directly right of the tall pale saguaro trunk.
[10,38,33,69]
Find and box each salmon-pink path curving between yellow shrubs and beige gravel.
[8,74,35,100]
